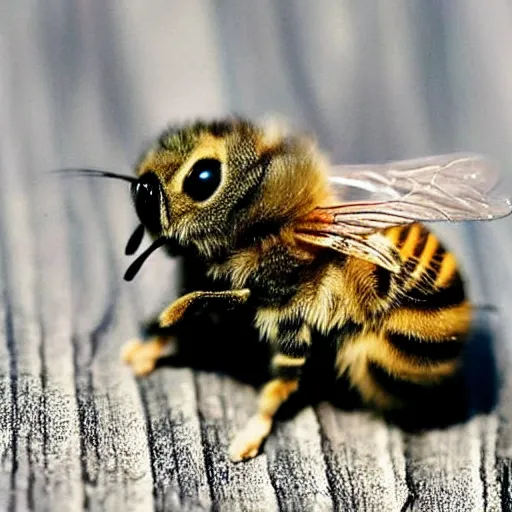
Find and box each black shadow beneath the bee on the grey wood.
[145,259,498,431]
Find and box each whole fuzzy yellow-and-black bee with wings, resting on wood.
[66,119,512,461]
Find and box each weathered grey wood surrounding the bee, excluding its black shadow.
[0,0,512,510]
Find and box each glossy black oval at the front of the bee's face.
[132,172,162,233]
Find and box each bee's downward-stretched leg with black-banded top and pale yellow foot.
[229,323,311,462]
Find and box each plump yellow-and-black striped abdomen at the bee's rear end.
[337,224,471,407]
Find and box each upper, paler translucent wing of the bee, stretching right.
[326,154,512,234]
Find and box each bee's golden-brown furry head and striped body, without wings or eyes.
[122,119,470,460]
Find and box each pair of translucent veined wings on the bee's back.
[295,154,512,272]
